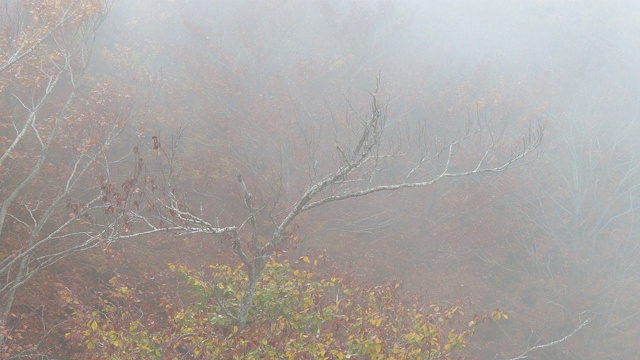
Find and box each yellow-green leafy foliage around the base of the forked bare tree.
[66,256,507,359]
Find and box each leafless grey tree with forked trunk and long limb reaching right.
[111,79,542,325]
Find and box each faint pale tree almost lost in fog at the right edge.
[485,92,640,358]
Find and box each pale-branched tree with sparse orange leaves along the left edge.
[0,0,123,344]
